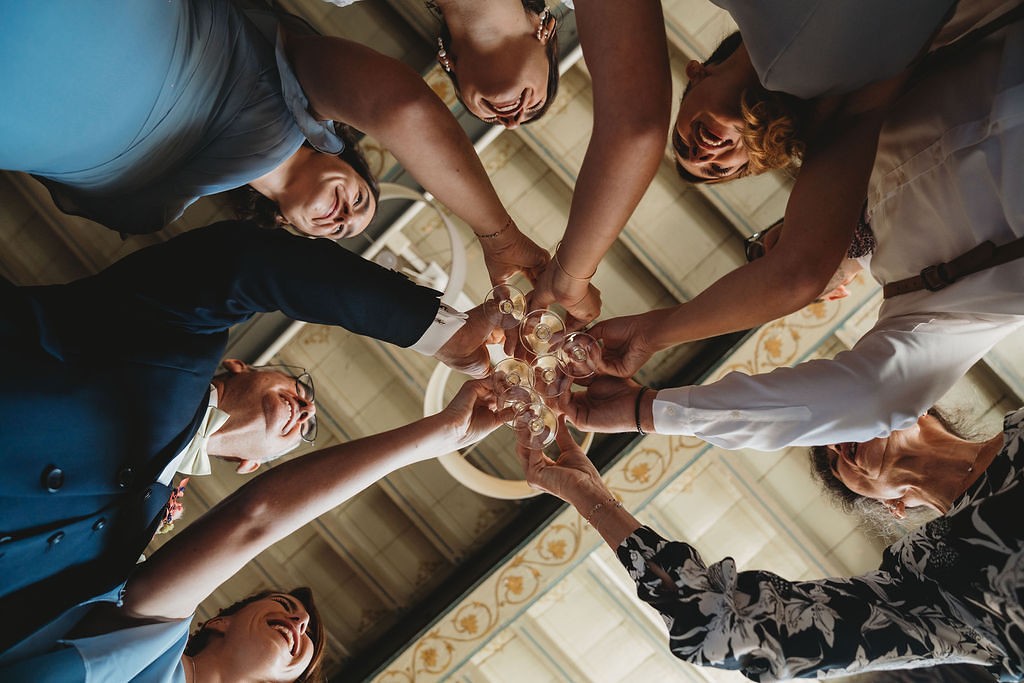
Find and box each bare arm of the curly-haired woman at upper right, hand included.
[591,109,885,377]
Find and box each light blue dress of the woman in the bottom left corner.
[0,584,191,683]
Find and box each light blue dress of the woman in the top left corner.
[0,0,342,232]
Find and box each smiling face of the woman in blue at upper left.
[272,146,377,240]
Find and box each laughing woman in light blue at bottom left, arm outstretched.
[0,380,508,683]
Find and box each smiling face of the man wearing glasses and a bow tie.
[210,359,316,471]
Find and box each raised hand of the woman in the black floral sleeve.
[516,417,605,504]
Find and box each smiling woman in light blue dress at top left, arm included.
[0,0,547,280]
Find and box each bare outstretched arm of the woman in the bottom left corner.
[124,381,501,620]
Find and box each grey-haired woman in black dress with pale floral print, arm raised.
[519,409,1024,681]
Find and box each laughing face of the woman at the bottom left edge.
[205,593,316,681]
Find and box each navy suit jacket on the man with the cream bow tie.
[0,222,439,649]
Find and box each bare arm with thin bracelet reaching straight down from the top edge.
[534,0,672,322]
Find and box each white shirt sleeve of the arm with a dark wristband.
[654,313,1024,451]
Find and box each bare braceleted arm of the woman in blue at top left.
[286,35,548,283]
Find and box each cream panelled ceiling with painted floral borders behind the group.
[0,0,1024,683]
